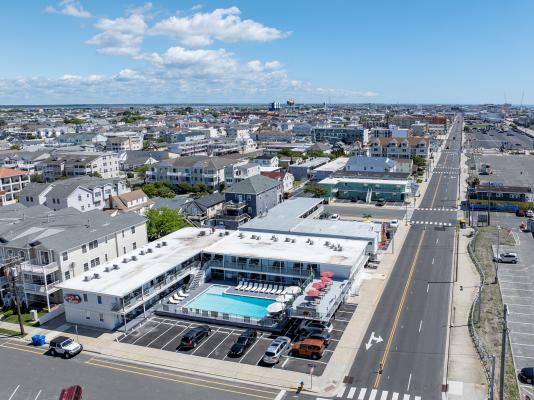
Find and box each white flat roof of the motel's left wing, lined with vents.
[59,228,223,297]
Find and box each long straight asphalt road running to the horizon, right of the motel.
[342,117,462,400]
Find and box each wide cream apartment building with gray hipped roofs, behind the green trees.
[146,156,238,190]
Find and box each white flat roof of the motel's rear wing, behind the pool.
[205,231,367,267]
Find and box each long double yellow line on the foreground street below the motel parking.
[85,358,278,400]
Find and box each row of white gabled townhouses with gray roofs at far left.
[19,176,131,212]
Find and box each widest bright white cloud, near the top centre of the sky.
[149,7,289,47]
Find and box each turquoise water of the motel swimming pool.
[187,285,274,319]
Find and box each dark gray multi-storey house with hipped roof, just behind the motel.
[216,175,283,229]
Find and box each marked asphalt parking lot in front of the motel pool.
[118,304,356,376]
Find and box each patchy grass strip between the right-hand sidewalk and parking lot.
[473,226,519,399]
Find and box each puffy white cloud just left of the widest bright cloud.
[86,14,147,56]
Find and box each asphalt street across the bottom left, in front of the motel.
[0,338,280,400]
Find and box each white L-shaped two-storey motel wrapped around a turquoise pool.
[57,228,368,331]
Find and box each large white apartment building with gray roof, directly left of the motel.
[0,206,148,308]
